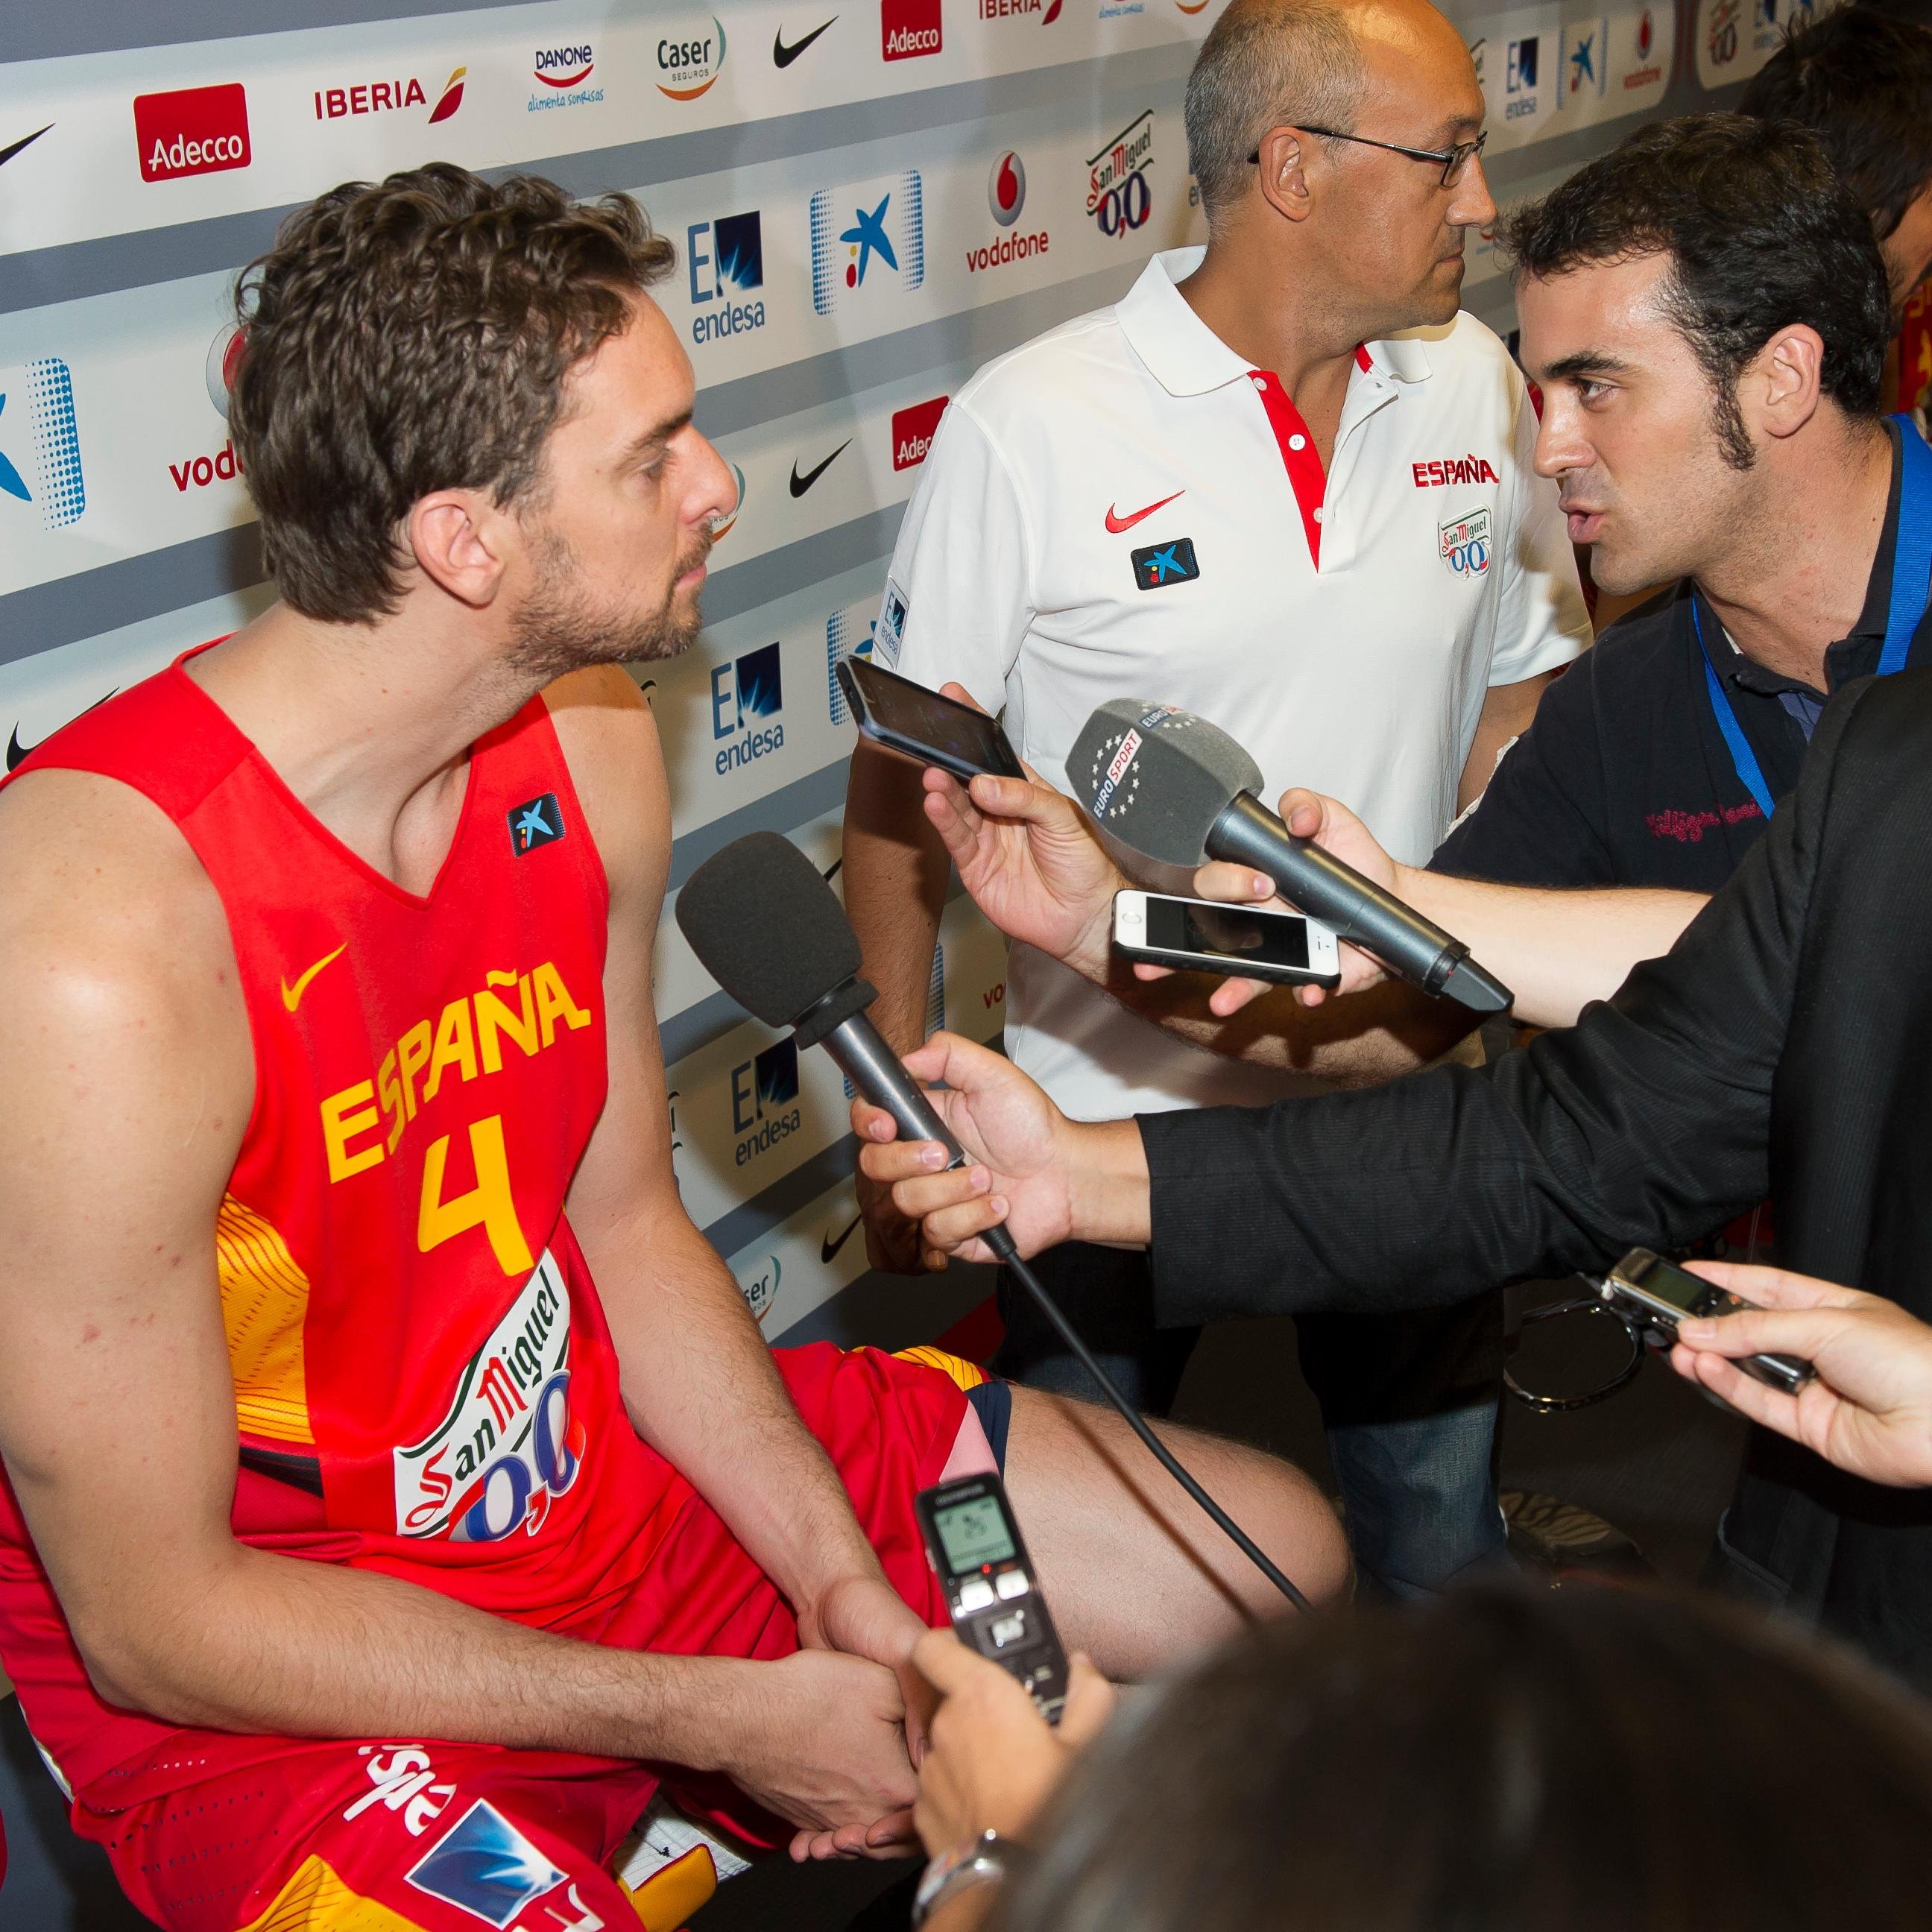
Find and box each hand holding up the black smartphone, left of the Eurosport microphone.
[924,684,1126,978]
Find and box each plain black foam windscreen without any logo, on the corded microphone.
[678,833,859,1026]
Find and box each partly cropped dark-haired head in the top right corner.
[1737,6,1932,309]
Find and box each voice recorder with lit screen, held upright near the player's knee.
[914,1476,1067,1723]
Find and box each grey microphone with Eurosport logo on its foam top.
[1067,698,1517,1012]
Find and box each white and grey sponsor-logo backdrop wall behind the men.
[0,0,1793,1777]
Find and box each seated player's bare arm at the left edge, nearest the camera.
[0,753,910,1825]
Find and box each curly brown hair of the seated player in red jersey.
[228,162,676,624]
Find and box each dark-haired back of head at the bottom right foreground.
[985,1588,1932,1932]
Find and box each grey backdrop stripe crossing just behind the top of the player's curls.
[0,42,1194,317]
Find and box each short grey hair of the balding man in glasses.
[1184,0,1366,226]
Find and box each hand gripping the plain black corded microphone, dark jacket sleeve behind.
[852,1034,1073,1269]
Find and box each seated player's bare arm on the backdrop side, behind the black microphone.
[547,670,924,1669]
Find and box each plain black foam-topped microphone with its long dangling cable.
[676,833,1308,1609]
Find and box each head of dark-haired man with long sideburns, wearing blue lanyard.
[1501,114,1892,593]
